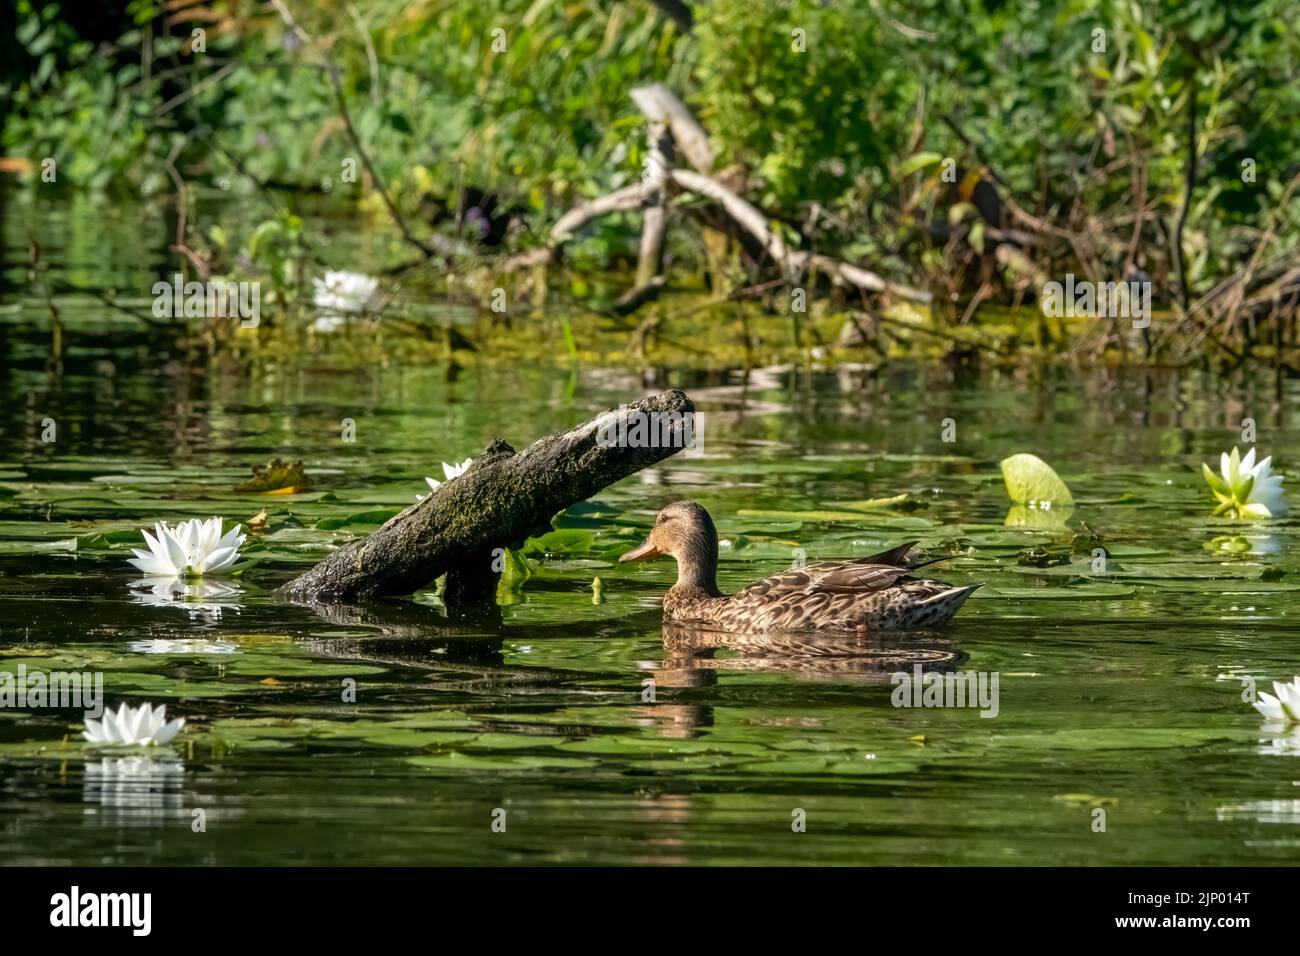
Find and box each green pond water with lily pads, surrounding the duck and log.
[0,200,1300,865]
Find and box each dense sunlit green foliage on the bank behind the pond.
[4,0,1300,348]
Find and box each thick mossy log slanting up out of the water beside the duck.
[285,389,694,606]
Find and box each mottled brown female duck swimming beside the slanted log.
[619,501,979,632]
